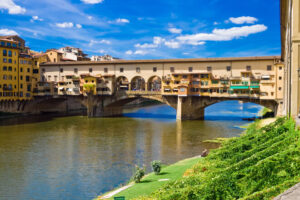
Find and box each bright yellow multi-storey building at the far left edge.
[0,38,19,100]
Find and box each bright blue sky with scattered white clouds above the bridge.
[0,0,281,59]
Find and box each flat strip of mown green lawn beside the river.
[110,158,201,200]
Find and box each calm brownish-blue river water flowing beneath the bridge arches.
[0,101,261,200]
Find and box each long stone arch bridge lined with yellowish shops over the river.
[29,56,285,120]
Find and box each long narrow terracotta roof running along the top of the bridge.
[39,56,281,66]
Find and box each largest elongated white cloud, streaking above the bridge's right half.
[176,24,267,45]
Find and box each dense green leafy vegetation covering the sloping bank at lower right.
[136,118,300,200]
